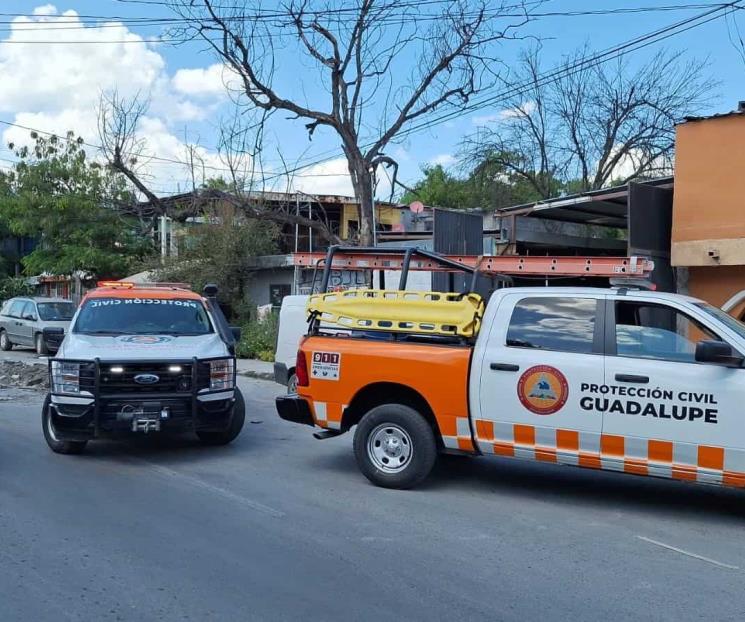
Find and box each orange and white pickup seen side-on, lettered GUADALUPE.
[277,249,745,488]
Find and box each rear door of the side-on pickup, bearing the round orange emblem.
[471,293,605,466]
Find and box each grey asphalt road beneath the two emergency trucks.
[0,379,745,622]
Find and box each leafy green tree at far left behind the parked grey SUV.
[0,132,152,277]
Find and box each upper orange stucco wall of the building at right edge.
[672,114,745,244]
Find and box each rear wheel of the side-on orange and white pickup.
[354,404,437,489]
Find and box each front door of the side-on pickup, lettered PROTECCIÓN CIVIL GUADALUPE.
[600,294,745,485]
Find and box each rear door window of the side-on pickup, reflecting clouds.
[507,297,597,354]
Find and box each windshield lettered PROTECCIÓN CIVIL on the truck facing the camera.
[73,298,213,335]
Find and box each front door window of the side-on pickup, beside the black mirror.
[615,301,720,363]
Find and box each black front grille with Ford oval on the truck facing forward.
[99,363,198,394]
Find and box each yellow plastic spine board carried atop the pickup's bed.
[306,289,484,337]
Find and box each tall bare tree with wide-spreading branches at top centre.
[170,0,540,244]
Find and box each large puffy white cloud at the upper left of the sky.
[0,4,235,191]
